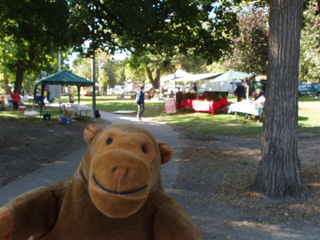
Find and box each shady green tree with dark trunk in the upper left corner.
[0,0,72,92]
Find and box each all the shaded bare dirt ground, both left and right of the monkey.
[0,116,320,240]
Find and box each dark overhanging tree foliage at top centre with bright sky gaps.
[70,0,238,88]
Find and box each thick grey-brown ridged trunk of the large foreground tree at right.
[254,0,308,197]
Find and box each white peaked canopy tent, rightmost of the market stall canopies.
[206,70,253,92]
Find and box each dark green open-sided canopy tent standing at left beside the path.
[34,70,96,119]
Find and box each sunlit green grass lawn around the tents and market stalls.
[0,96,320,137]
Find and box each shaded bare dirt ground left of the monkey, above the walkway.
[0,115,108,187]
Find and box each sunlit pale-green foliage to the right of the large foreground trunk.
[300,1,320,82]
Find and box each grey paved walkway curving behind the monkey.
[0,112,181,206]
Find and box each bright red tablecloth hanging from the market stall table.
[181,98,228,114]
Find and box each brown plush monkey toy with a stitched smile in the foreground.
[0,124,202,240]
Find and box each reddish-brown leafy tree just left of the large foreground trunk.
[225,3,268,74]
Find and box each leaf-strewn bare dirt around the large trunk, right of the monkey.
[170,136,320,240]
